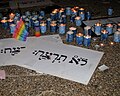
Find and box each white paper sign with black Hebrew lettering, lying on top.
[3,40,103,85]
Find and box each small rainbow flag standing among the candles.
[13,18,28,41]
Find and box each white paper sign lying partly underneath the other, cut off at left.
[0,34,62,66]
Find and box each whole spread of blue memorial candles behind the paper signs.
[1,7,120,46]
